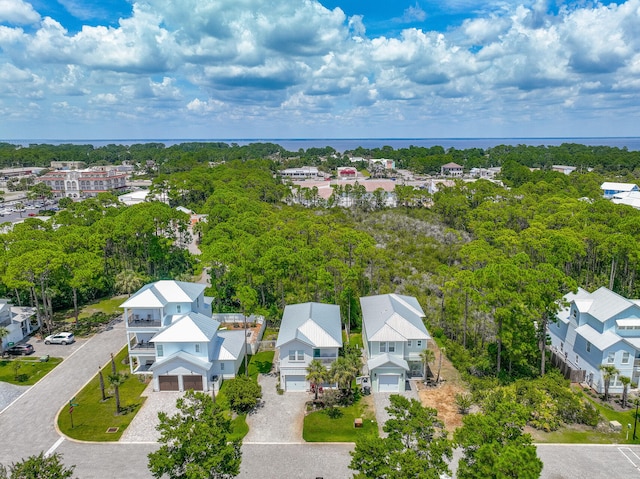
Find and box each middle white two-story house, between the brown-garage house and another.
[276,303,342,391]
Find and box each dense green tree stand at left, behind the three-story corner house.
[0,194,193,330]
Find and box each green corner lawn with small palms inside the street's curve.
[58,347,147,442]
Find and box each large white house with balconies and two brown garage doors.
[121,280,245,391]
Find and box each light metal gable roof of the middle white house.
[276,303,342,348]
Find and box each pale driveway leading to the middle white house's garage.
[243,374,311,444]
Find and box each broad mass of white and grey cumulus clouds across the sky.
[0,0,640,137]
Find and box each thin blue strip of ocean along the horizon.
[0,137,640,153]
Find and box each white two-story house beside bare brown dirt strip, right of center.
[360,294,431,392]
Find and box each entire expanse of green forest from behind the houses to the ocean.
[0,144,640,442]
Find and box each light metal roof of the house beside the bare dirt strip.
[360,294,430,341]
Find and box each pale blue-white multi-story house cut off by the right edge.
[548,287,640,393]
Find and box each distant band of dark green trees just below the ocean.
[0,142,640,178]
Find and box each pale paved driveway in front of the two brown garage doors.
[120,383,184,442]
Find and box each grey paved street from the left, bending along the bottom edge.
[6,324,640,479]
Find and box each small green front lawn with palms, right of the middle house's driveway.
[302,396,378,442]
